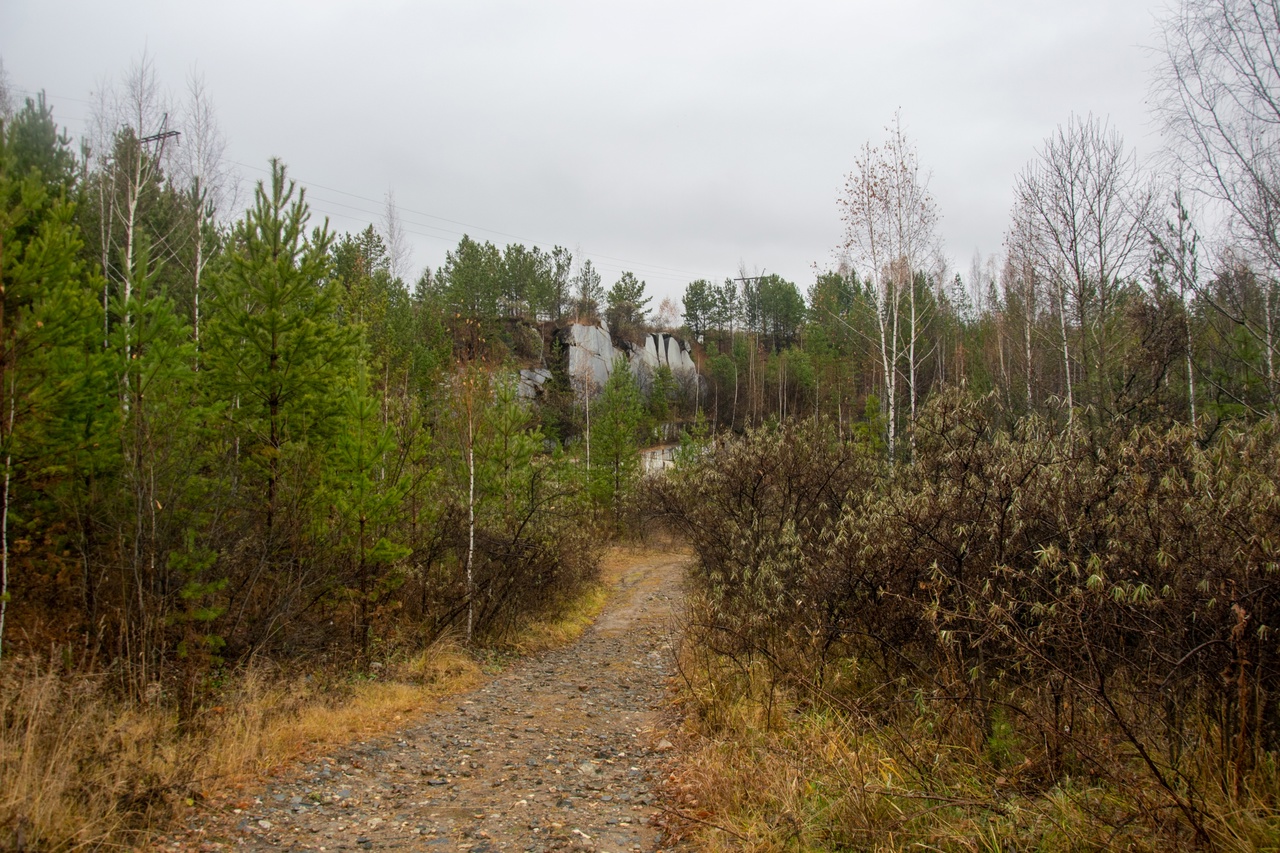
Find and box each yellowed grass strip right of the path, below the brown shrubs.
[668,640,1280,853]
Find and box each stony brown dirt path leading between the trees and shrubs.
[166,551,687,853]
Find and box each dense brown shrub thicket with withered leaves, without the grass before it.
[649,392,1280,841]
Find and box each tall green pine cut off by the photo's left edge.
[0,112,111,653]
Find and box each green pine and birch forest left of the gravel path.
[0,71,676,720]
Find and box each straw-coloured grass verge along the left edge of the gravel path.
[0,568,619,850]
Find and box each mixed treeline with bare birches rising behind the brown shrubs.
[682,117,1280,448]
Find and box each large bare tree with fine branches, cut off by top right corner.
[1153,0,1280,402]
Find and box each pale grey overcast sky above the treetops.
[0,0,1161,305]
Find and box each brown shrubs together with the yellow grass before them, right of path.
[649,394,1280,850]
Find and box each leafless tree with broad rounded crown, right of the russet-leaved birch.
[1014,115,1155,418]
